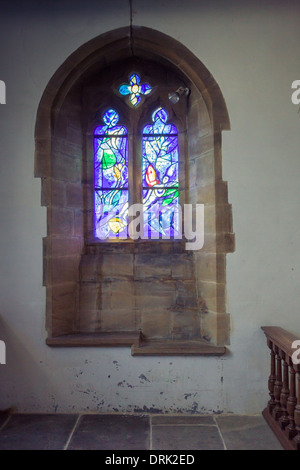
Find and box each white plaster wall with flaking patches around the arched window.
[0,0,300,413]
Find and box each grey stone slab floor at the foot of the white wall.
[0,413,282,450]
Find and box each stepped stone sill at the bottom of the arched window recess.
[46,332,226,356]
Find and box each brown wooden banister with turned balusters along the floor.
[262,326,300,450]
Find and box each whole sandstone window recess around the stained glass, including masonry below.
[35,26,234,355]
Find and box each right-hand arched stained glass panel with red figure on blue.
[142,108,181,239]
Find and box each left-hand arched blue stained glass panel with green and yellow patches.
[94,109,128,239]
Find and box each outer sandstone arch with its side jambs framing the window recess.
[35,26,234,347]
